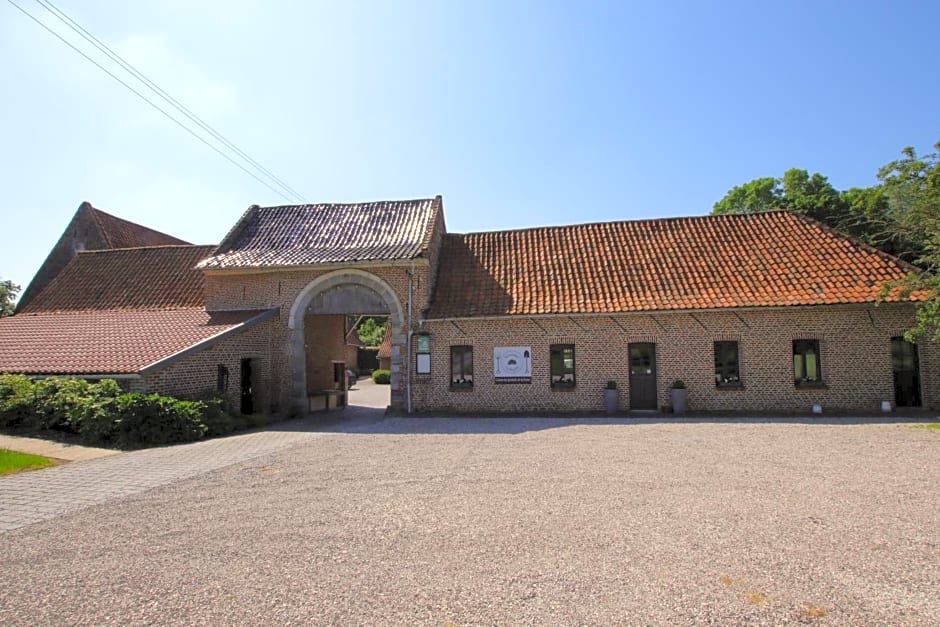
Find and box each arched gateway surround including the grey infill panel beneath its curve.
[287,268,406,412]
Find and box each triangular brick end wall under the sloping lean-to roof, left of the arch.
[141,320,279,413]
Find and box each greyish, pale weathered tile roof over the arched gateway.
[200,196,441,269]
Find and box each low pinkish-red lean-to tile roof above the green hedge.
[0,308,268,374]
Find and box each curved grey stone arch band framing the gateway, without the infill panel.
[287,268,407,413]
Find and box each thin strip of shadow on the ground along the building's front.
[270,407,940,435]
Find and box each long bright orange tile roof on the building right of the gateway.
[428,212,916,318]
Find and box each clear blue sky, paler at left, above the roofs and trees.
[0,0,940,287]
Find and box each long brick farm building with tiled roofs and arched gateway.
[0,196,940,414]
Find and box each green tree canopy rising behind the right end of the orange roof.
[712,142,940,341]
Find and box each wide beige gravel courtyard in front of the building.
[0,419,940,626]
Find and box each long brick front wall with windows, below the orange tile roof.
[409,305,940,413]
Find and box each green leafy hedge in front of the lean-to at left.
[0,375,223,448]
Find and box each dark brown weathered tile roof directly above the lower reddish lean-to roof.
[21,246,215,313]
